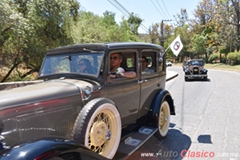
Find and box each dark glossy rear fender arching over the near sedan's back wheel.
[148,90,175,124]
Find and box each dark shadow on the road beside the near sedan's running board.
[125,124,191,160]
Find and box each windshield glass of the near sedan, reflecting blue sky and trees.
[39,52,103,77]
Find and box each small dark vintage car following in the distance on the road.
[184,59,208,81]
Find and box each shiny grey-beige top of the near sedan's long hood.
[0,79,99,109]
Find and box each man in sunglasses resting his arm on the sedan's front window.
[110,53,136,78]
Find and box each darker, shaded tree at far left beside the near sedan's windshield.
[0,0,79,81]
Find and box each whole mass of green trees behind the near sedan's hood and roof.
[0,0,142,82]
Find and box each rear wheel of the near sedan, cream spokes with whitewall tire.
[158,101,170,138]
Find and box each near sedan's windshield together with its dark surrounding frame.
[38,51,104,79]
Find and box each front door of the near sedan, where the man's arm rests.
[107,49,140,125]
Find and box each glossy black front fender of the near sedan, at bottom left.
[0,137,106,160]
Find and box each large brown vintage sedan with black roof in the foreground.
[0,42,175,159]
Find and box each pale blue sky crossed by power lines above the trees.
[78,0,200,33]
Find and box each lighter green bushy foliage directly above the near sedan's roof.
[68,12,139,43]
